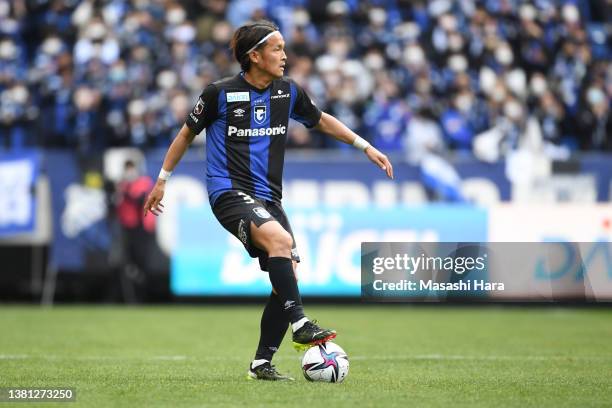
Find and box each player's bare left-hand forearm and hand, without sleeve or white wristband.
[144,125,196,216]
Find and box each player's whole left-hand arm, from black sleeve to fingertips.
[143,84,219,215]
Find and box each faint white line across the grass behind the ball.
[0,354,612,361]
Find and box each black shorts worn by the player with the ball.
[212,190,300,271]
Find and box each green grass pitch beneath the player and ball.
[0,305,612,408]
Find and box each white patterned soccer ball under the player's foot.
[302,342,349,382]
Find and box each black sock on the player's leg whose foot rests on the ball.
[268,257,305,323]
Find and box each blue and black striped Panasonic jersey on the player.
[185,73,321,204]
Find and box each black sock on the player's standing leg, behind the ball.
[255,292,289,361]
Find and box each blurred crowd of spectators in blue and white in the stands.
[0,0,612,161]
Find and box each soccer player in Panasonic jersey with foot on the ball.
[144,21,393,380]
